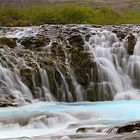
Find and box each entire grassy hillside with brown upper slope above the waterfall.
[0,0,140,26]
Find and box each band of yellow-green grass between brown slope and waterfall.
[0,4,140,26]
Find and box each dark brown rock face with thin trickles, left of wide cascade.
[0,25,138,104]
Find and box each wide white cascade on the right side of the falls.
[88,31,140,100]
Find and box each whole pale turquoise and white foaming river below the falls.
[0,100,140,139]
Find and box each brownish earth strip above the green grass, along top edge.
[0,0,140,10]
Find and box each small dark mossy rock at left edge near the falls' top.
[0,37,16,48]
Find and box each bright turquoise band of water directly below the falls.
[0,100,140,122]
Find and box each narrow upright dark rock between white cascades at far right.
[127,34,136,55]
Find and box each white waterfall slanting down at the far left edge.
[0,65,32,102]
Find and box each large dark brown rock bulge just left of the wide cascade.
[70,48,95,88]
